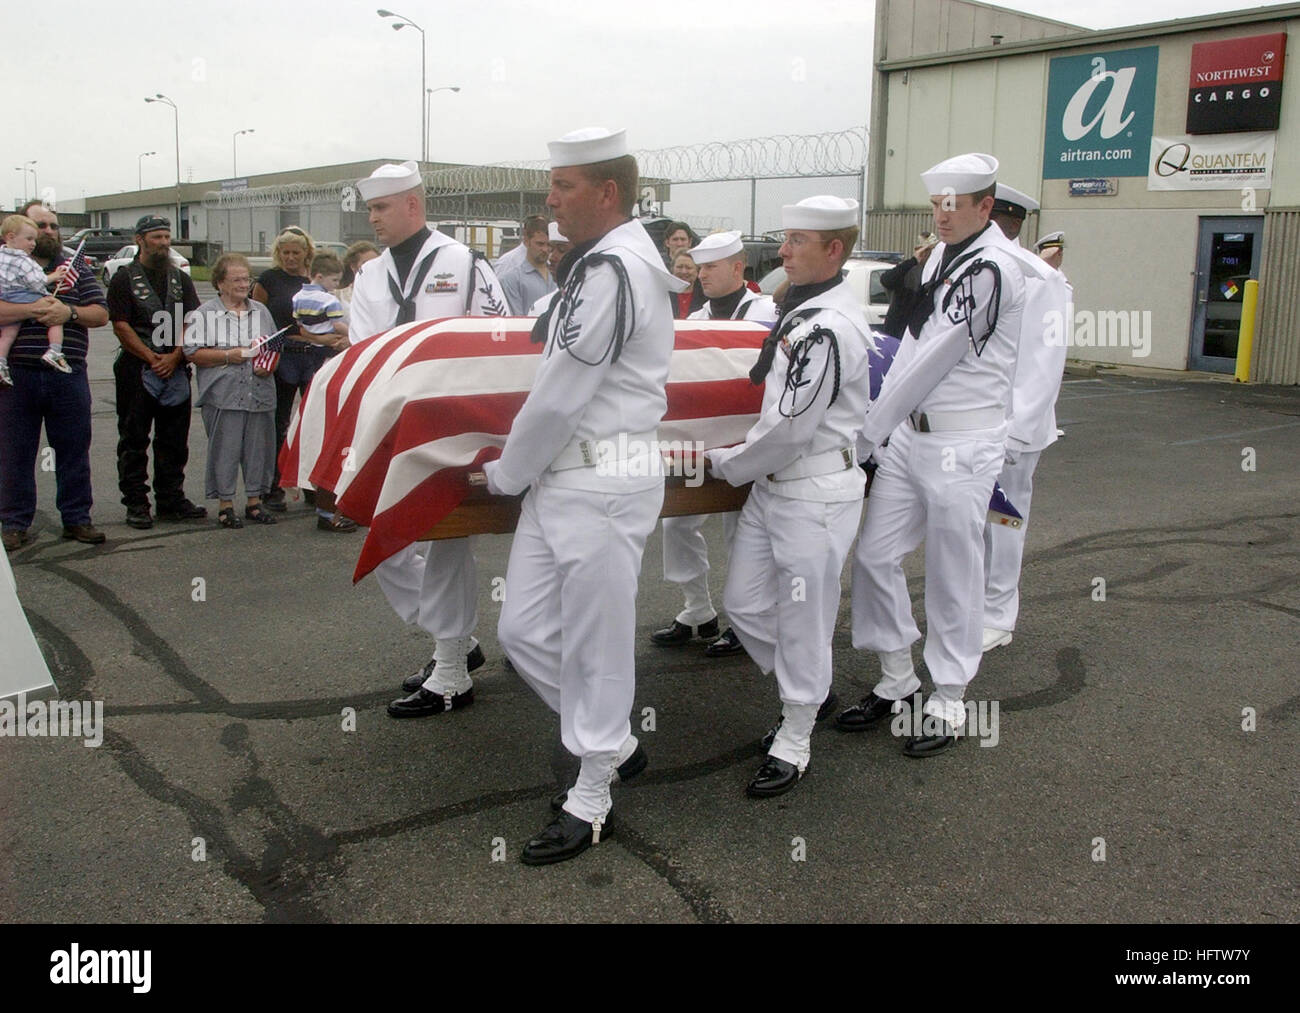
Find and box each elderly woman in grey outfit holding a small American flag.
[185,254,276,528]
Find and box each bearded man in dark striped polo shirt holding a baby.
[0,202,108,551]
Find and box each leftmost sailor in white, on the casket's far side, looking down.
[351,161,507,718]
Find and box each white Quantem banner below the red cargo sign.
[1147,131,1277,190]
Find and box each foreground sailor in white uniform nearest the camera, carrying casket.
[485,127,686,865]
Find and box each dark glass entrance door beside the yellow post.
[1187,218,1264,373]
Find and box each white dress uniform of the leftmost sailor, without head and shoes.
[350,233,506,693]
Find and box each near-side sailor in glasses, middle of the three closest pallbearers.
[706,196,875,798]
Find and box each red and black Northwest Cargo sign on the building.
[1187,33,1287,134]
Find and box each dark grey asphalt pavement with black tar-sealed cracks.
[0,313,1300,922]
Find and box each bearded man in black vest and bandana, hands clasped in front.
[108,215,208,529]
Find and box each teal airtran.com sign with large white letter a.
[1043,46,1160,179]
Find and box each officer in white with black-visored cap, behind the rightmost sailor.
[983,183,1074,651]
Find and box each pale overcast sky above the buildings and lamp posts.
[0,0,1279,229]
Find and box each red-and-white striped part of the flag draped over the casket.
[280,317,767,580]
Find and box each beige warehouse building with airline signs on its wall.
[865,0,1300,384]
